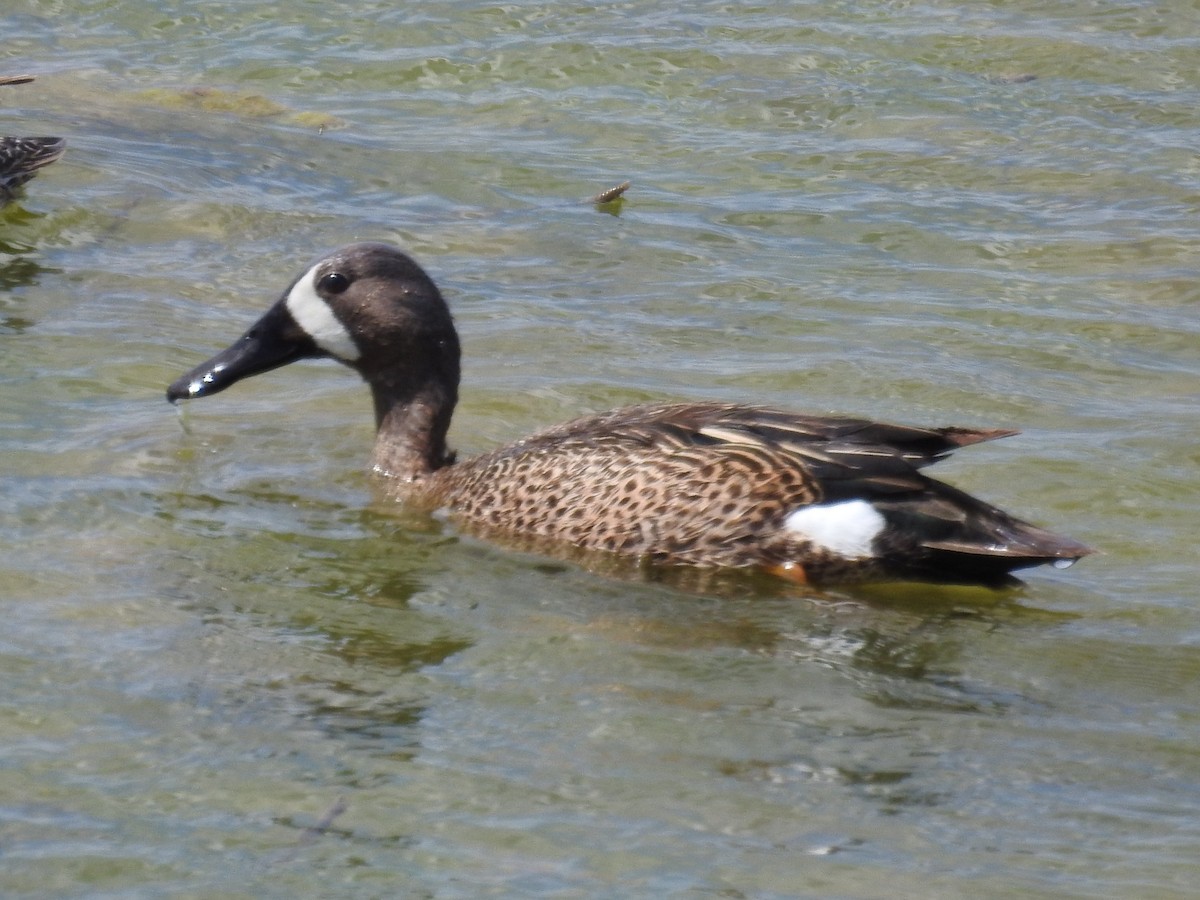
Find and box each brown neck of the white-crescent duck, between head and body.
[371,383,458,484]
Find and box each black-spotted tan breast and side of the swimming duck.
[393,404,907,578]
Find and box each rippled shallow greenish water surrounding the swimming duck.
[0,0,1200,898]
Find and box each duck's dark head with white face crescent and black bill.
[167,244,460,403]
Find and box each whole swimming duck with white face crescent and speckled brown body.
[167,244,1092,586]
